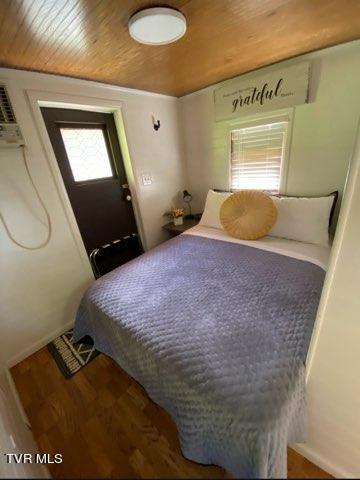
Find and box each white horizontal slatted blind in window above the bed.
[231,121,288,192]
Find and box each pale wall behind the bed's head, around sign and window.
[180,42,360,218]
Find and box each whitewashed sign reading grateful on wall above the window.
[214,62,310,121]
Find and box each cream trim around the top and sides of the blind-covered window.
[227,108,294,195]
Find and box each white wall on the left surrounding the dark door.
[0,69,185,363]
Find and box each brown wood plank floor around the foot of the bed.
[11,348,331,478]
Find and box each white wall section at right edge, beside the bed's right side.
[299,125,360,478]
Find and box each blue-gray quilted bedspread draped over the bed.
[75,235,325,478]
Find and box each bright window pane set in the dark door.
[60,128,113,182]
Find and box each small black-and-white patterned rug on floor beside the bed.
[47,329,100,378]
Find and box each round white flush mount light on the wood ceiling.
[129,7,186,45]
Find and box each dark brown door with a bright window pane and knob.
[41,108,137,254]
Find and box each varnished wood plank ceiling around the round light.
[0,0,360,96]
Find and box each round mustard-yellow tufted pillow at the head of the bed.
[220,190,277,240]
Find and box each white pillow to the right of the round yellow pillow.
[268,195,334,245]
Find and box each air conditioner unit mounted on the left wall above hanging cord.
[0,85,25,148]
